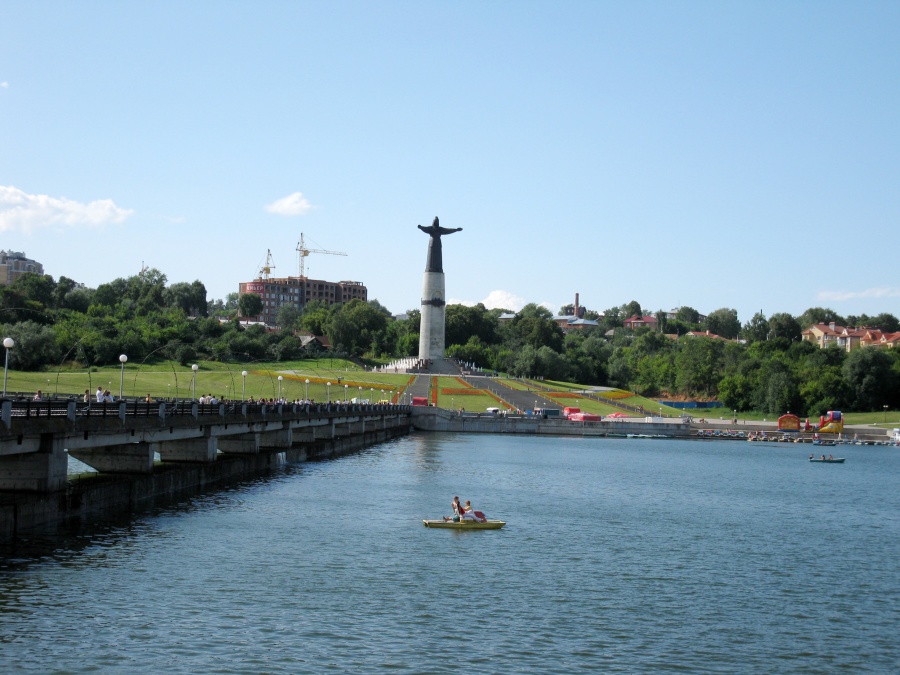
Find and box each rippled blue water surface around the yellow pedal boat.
[0,435,900,673]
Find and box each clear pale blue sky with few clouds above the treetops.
[0,0,900,322]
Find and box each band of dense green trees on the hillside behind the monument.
[0,269,900,416]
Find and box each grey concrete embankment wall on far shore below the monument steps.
[412,407,691,438]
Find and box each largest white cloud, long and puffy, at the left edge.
[0,185,134,232]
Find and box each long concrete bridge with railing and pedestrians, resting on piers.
[0,399,410,493]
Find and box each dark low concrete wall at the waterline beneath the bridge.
[0,426,409,539]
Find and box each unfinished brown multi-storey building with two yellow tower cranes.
[238,234,369,326]
